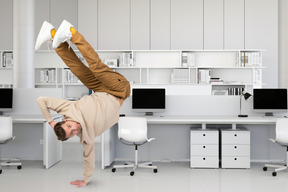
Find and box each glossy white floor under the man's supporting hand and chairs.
[0,145,288,192]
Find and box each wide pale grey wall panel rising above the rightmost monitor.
[245,0,278,87]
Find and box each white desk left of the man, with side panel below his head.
[11,114,62,169]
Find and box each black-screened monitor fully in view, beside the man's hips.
[132,88,166,115]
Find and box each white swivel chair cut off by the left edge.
[0,116,22,174]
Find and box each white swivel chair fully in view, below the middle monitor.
[112,117,158,176]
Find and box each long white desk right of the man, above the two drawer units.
[101,116,278,169]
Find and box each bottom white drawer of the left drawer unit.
[190,156,219,168]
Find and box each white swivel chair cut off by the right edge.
[263,118,288,176]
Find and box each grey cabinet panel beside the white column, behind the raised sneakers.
[35,0,51,50]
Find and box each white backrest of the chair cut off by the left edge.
[0,116,13,143]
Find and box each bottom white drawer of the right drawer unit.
[221,156,250,168]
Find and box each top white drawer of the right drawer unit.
[221,131,250,144]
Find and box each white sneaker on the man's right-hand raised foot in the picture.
[52,20,73,49]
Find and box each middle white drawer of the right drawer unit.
[221,145,250,157]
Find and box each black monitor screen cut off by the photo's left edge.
[0,88,13,111]
